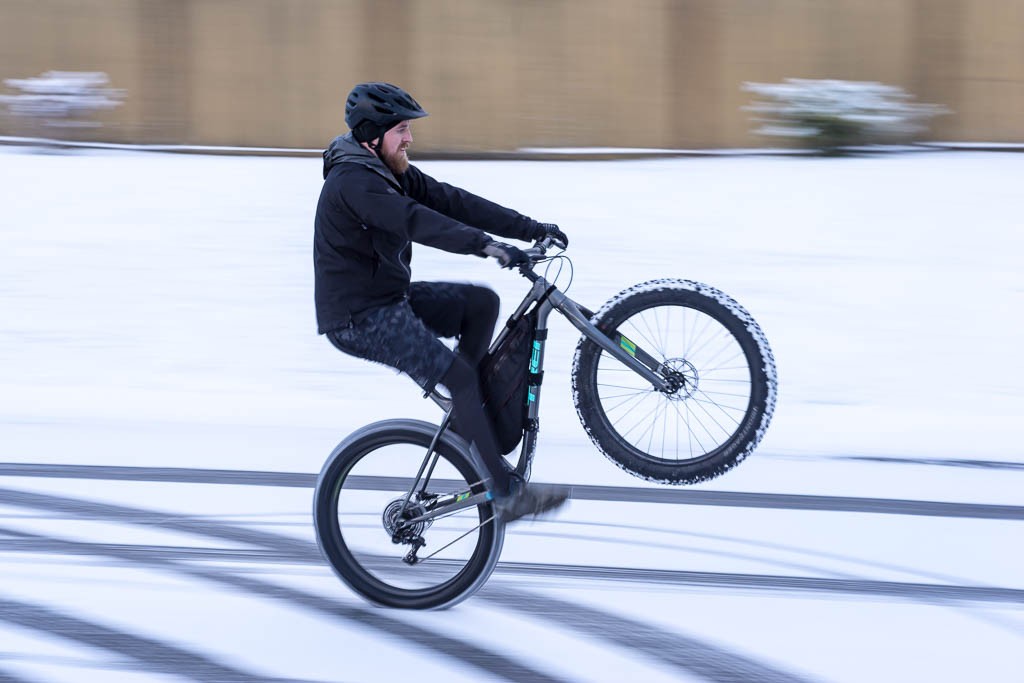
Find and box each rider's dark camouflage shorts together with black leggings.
[327,283,508,488]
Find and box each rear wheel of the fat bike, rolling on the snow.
[313,420,504,609]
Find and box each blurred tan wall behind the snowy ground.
[0,0,1024,152]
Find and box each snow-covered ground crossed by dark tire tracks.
[0,147,1024,682]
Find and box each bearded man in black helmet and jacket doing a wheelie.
[313,82,568,522]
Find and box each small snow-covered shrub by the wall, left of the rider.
[0,71,124,131]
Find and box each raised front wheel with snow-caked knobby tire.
[572,280,776,484]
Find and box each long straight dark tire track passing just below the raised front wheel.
[0,463,1024,520]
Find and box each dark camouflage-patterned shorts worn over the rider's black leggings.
[327,283,499,389]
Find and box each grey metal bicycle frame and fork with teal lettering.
[401,255,671,527]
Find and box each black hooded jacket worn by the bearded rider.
[313,133,543,334]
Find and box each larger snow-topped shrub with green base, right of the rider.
[743,78,948,154]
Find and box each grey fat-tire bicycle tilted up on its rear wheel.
[313,241,776,609]
